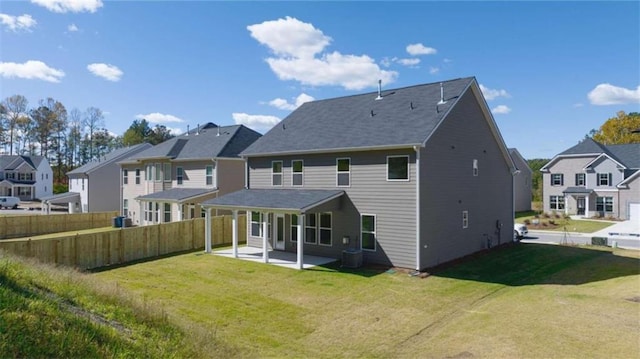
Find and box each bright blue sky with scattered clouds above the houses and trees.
[0,0,640,158]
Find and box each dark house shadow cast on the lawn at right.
[432,243,640,286]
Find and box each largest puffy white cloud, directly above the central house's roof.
[247,17,398,90]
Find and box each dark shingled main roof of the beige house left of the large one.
[123,123,261,162]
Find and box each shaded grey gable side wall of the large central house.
[420,88,514,268]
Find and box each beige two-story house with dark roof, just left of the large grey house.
[119,123,261,225]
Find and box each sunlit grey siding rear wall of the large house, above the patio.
[247,149,416,268]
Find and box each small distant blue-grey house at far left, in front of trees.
[0,155,53,201]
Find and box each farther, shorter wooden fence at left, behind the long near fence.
[0,211,118,239]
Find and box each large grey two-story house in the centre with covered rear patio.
[203,78,515,270]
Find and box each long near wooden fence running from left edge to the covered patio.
[0,216,246,269]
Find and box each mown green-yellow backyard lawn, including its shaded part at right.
[92,243,640,358]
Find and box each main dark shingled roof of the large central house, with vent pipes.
[241,77,476,157]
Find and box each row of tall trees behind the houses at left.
[0,95,173,183]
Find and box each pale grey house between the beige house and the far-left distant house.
[42,143,152,213]
